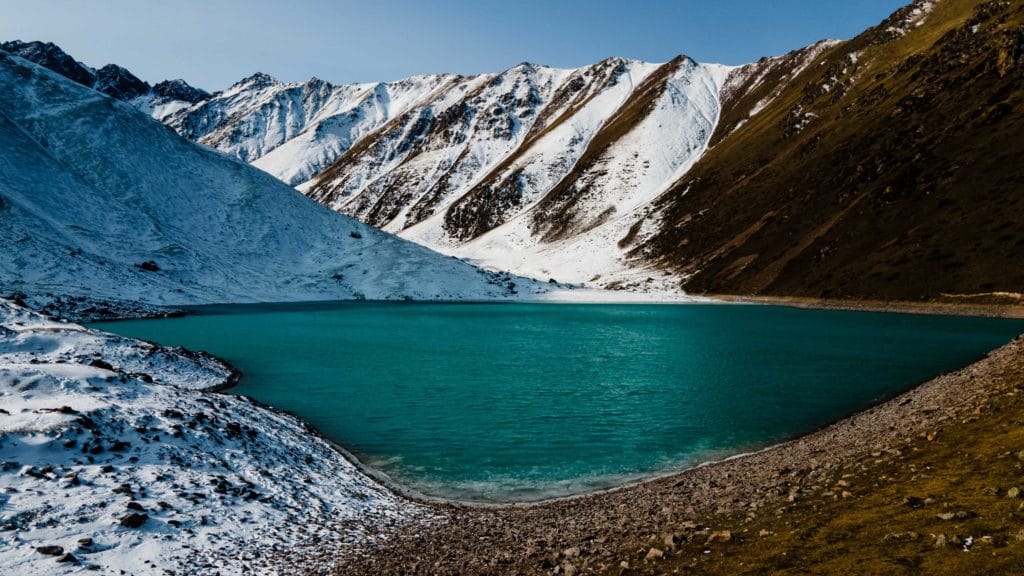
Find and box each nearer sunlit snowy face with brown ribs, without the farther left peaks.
[306,57,731,290]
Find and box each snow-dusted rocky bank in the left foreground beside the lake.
[0,300,429,576]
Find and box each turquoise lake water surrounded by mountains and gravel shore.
[90,302,1024,501]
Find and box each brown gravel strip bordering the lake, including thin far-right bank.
[333,298,1024,574]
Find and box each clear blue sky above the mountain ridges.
[0,0,909,90]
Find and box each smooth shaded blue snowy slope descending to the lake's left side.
[0,51,536,304]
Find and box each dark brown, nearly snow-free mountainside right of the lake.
[631,0,1024,299]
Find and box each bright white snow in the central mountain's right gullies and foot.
[398,60,732,291]
